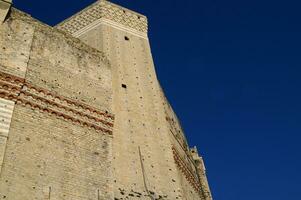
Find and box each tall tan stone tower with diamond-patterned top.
[57,1,211,199]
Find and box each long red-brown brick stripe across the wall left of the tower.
[0,72,114,134]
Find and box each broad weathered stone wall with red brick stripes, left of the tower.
[0,9,114,200]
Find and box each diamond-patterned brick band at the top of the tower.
[56,0,148,36]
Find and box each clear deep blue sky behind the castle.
[14,0,301,200]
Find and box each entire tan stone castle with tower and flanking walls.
[0,0,212,200]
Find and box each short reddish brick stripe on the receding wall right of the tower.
[172,147,202,197]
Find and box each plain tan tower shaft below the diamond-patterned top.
[79,21,185,199]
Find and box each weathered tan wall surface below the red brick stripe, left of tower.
[0,105,112,200]
